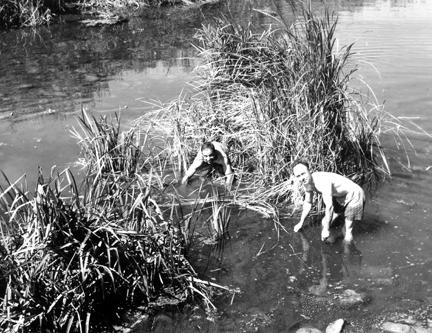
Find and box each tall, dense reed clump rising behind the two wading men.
[168,8,389,202]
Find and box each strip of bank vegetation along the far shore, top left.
[0,0,205,29]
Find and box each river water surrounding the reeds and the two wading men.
[0,0,432,332]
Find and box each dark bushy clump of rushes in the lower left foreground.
[0,114,212,332]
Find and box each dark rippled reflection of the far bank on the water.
[0,13,199,120]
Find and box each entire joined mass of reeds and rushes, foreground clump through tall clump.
[0,1,412,332]
